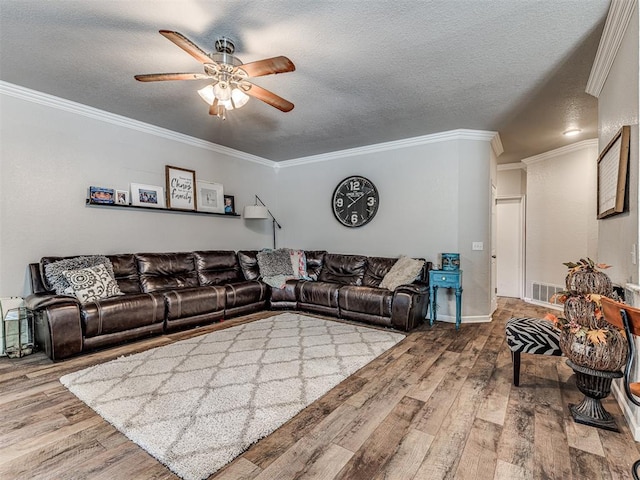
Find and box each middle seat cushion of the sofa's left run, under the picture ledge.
[164,286,226,321]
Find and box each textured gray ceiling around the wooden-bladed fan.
[0,0,609,163]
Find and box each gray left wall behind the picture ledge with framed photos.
[0,88,277,297]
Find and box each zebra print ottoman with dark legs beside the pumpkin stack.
[505,318,562,387]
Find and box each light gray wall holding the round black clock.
[274,134,491,320]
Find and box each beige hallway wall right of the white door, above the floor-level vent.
[523,140,600,298]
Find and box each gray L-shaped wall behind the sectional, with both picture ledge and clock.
[0,87,495,320]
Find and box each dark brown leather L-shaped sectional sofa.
[25,250,431,360]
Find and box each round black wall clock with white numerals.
[331,175,380,227]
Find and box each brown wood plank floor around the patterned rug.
[0,298,640,480]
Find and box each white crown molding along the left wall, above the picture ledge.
[0,80,276,168]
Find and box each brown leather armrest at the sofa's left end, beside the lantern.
[25,294,83,360]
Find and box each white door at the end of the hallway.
[496,196,524,298]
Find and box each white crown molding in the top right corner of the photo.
[585,0,637,98]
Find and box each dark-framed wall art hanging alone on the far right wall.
[598,125,631,219]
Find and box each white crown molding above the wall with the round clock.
[276,129,498,168]
